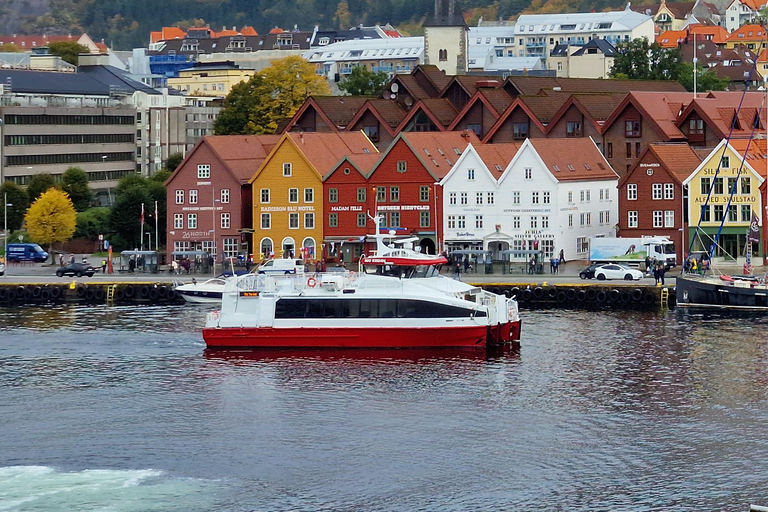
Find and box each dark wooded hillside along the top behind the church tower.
[6,0,626,50]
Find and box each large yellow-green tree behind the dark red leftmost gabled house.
[213,55,330,135]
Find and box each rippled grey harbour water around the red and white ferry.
[0,306,768,512]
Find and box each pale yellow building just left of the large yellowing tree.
[168,61,255,96]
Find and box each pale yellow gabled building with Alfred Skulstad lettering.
[683,139,766,259]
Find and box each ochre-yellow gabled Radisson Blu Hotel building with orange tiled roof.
[249,132,378,261]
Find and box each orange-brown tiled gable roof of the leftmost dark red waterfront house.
[165,135,280,185]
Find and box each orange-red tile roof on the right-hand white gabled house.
[528,137,618,181]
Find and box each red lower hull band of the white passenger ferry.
[203,325,520,348]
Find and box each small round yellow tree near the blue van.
[24,188,77,252]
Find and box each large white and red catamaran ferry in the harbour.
[203,225,520,348]
